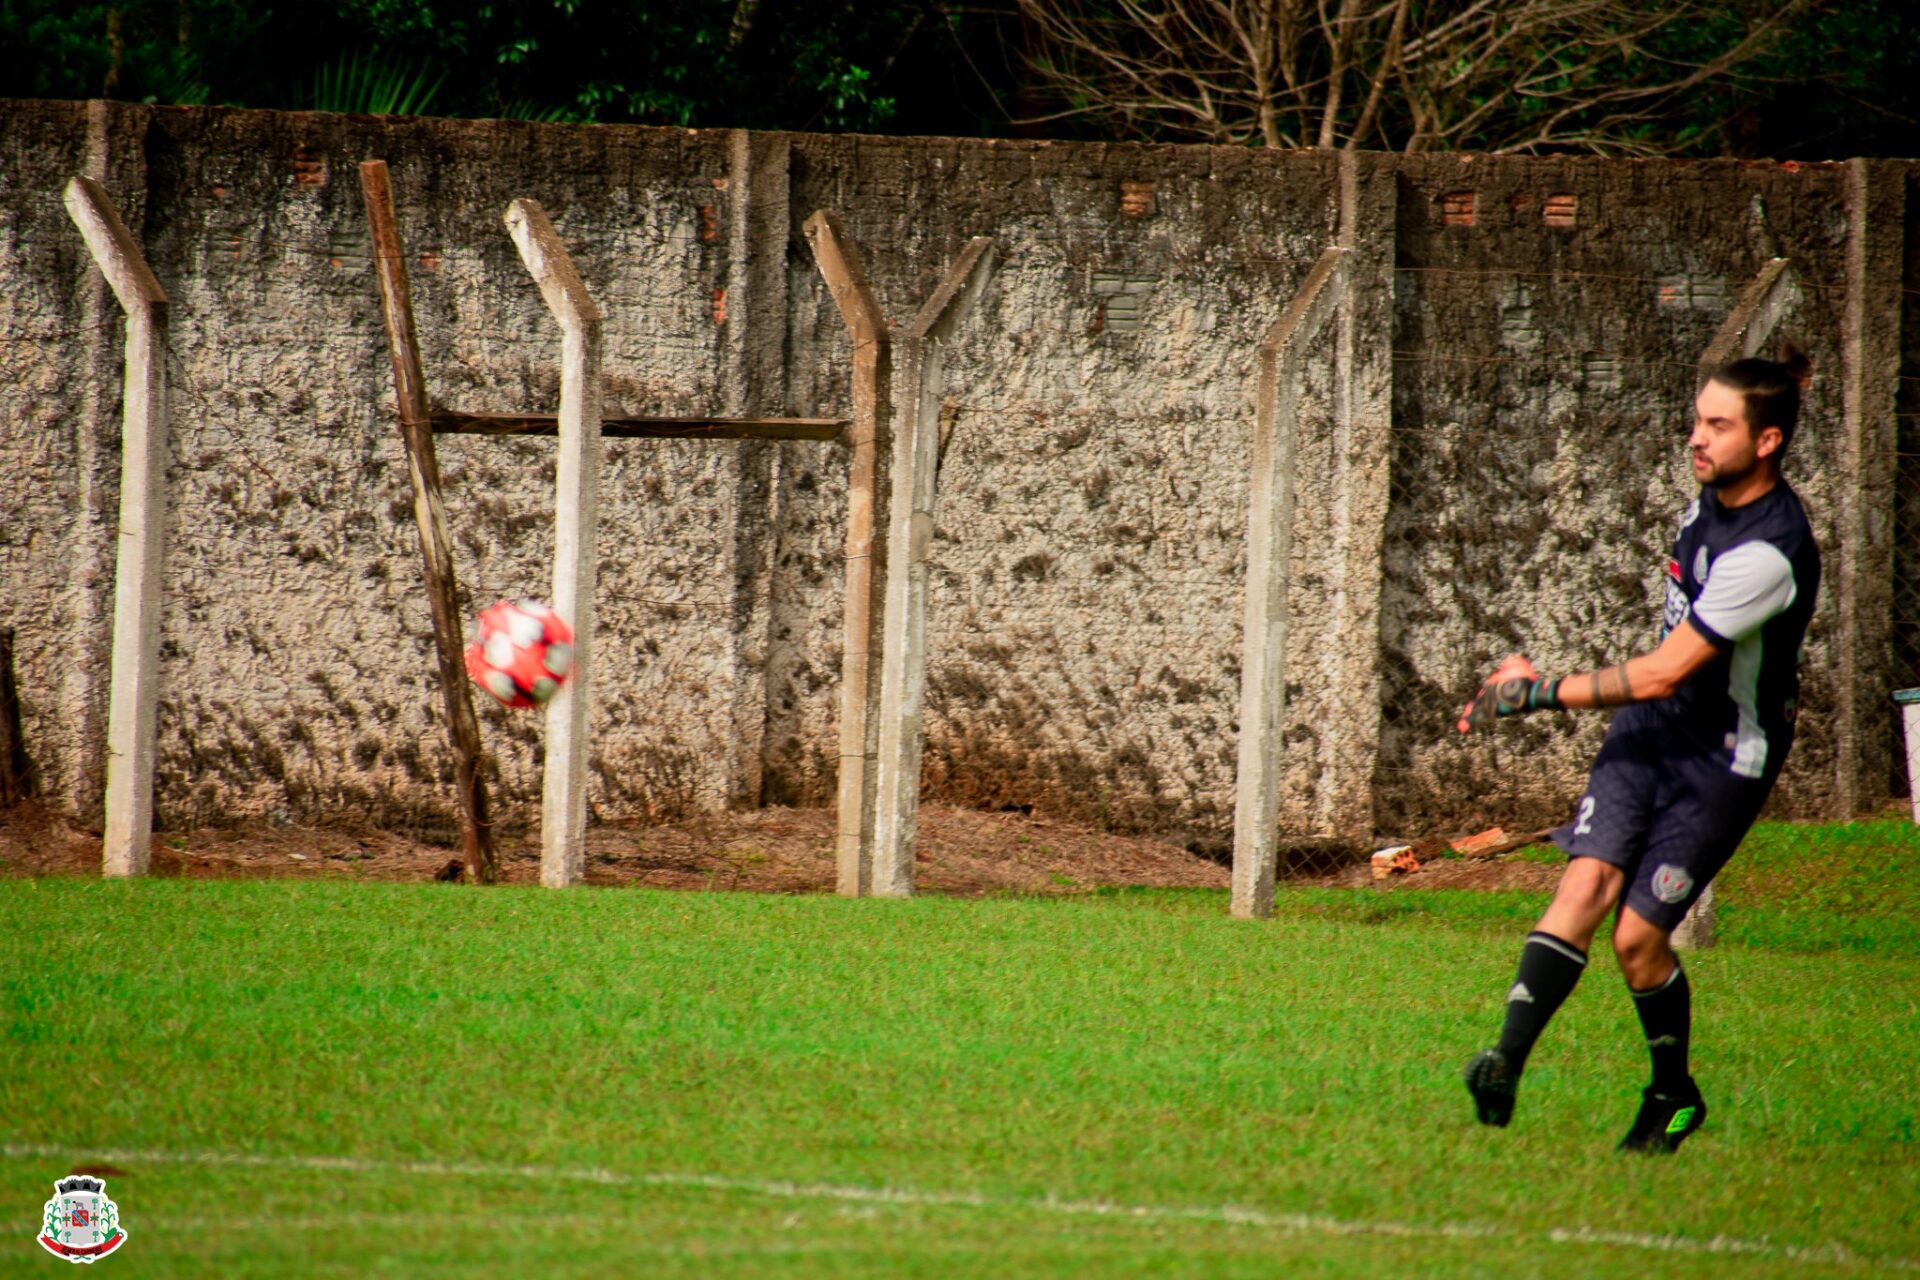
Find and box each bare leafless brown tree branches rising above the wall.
[1020,0,1814,155]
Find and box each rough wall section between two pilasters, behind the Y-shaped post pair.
[772,138,1332,844]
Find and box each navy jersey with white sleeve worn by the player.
[1649,480,1820,779]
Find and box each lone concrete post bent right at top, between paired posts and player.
[1231,248,1350,919]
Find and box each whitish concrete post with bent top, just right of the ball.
[507,200,601,889]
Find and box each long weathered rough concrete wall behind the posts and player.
[0,102,1912,846]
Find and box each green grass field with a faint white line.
[0,823,1920,1276]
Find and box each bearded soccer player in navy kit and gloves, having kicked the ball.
[1455,351,1820,1153]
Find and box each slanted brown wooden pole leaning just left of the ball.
[361,159,499,885]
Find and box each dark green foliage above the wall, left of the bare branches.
[0,0,975,132]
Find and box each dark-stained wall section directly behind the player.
[1377,157,1847,829]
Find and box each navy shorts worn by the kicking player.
[1553,704,1786,931]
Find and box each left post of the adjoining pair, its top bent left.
[804,209,893,898]
